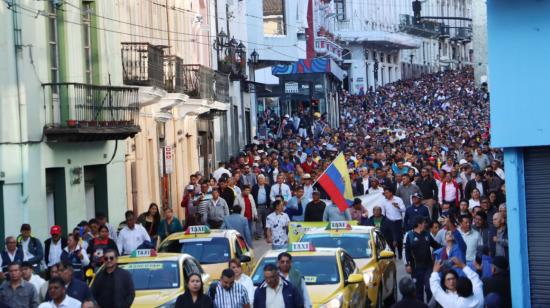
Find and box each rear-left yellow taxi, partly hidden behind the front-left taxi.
[159,226,254,279]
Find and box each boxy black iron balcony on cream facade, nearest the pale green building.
[121,43,164,88]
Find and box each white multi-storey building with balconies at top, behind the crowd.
[334,0,471,93]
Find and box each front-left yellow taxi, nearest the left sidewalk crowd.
[91,249,210,308]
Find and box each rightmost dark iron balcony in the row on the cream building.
[182,64,229,102]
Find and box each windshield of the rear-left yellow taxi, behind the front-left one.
[159,237,231,265]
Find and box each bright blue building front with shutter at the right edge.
[487,0,550,307]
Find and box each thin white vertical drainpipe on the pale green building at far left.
[12,0,29,222]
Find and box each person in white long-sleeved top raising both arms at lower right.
[430,258,484,308]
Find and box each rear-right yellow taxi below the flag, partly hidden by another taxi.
[300,221,397,307]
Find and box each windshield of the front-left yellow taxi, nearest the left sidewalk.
[119,261,180,290]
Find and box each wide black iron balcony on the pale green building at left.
[42,83,140,142]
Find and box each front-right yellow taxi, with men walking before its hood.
[251,242,368,308]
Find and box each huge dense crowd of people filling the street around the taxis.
[0,68,510,308]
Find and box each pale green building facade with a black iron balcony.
[0,0,140,239]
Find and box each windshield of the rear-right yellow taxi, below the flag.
[300,233,372,259]
